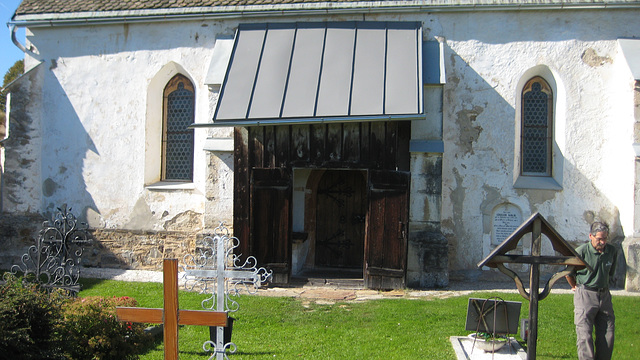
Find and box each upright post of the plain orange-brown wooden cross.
[163,259,178,360]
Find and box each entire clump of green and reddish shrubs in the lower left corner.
[0,276,153,360]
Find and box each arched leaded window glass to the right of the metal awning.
[521,76,553,176]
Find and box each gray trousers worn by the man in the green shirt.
[573,285,616,360]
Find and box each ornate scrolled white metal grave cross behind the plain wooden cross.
[183,223,272,360]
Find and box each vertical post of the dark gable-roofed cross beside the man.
[527,219,542,360]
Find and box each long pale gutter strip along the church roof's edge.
[8,0,640,27]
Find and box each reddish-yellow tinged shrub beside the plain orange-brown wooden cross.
[61,296,153,360]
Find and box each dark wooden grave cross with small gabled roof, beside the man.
[478,213,591,360]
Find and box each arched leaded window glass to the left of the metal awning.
[162,75,195,181]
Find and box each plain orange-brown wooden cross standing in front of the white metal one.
[116,259,227,360]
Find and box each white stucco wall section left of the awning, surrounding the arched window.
[21,22,239,230]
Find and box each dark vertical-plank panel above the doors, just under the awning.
[252,121,411,171]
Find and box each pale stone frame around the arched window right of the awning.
[513,65,566,191]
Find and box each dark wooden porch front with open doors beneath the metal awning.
[233,122,410,289]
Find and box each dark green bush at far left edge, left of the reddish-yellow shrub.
[0,276,62,359]
